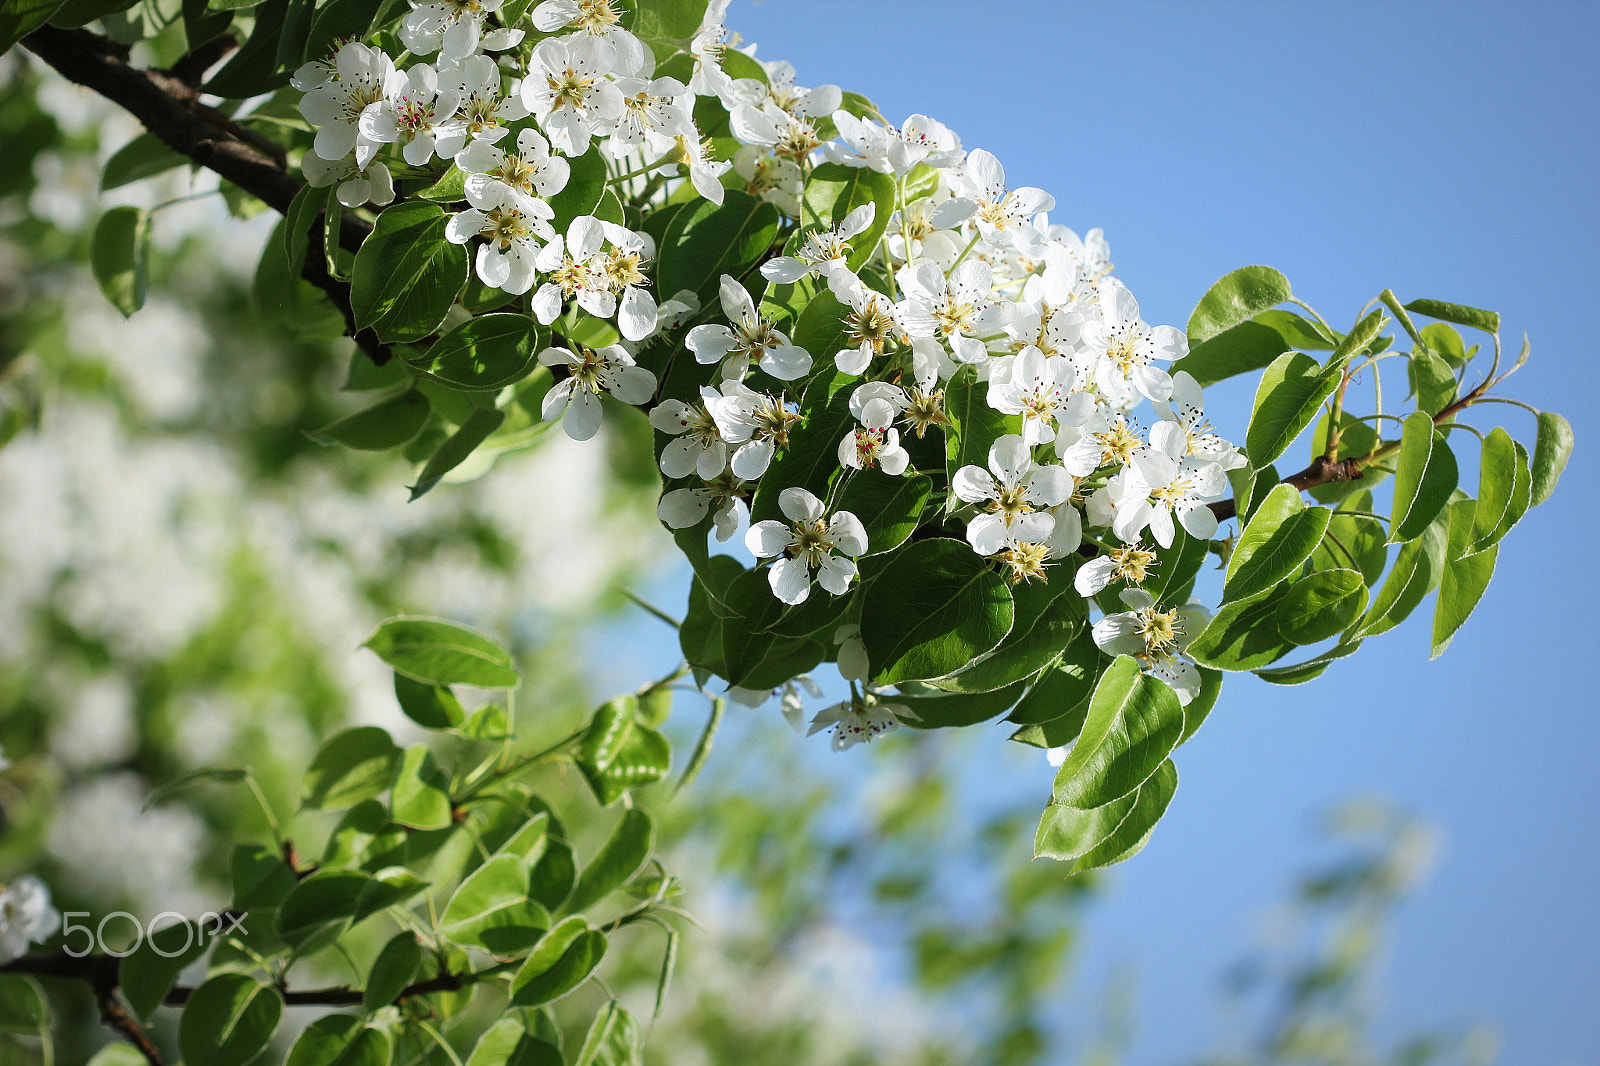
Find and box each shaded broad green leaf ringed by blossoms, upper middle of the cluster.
[656,189,779,306]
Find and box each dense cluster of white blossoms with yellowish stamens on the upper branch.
[294,0,1245,739]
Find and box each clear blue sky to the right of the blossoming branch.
[704,0,1600,1066]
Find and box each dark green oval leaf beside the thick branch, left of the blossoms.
[350,200,469,341]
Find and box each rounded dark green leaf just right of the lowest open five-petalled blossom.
[861,538,1013,685]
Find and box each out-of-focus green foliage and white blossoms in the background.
[0,51,1493,1066]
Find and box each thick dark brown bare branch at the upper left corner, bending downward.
[22,26,389,365]
